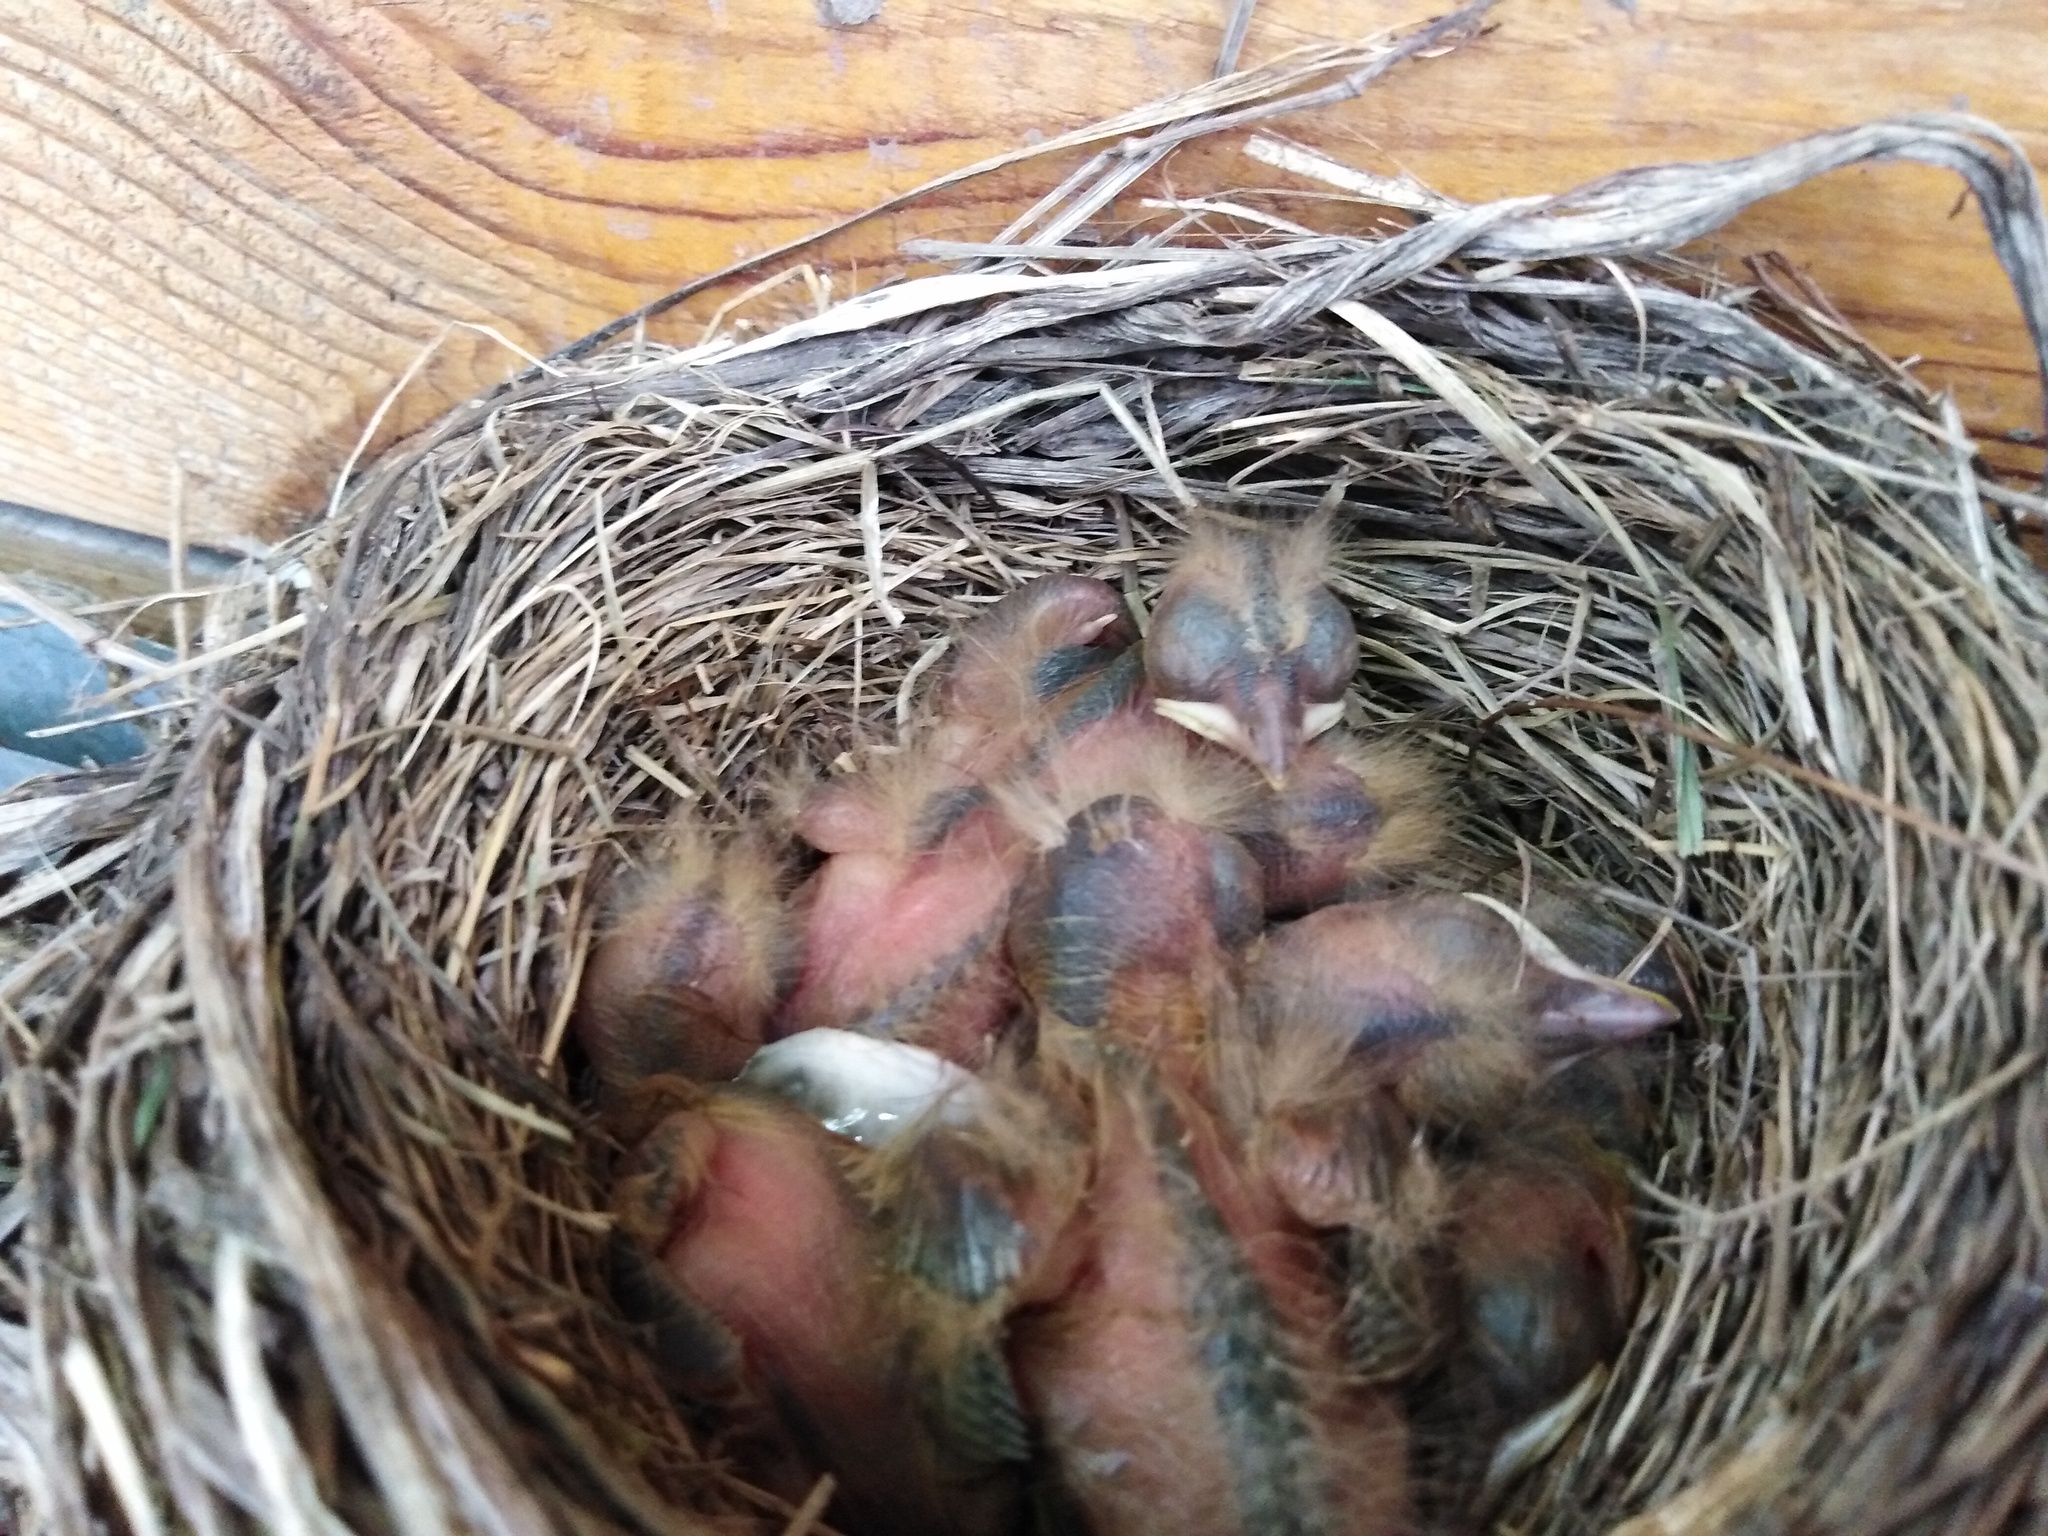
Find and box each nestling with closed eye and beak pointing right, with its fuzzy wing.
[1225,895,1675,1376]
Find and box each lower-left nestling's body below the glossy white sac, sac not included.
[612,1079,1030,1536]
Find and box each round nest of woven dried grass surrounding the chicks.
[0,20,2048,1536]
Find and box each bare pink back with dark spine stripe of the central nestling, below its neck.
[1012,1087,1407,1536]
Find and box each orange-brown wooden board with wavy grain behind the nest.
[0,0,2048,543]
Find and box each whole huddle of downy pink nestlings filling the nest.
[575,516,1679,1536]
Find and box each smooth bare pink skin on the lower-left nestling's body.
[623,1094,1018,1536]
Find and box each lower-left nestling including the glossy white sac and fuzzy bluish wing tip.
[612,1030,1083,1536]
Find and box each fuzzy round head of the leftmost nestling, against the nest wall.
[573,825,793,1096]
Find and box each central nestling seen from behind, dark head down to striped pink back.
[1010,780,1407,1536]
